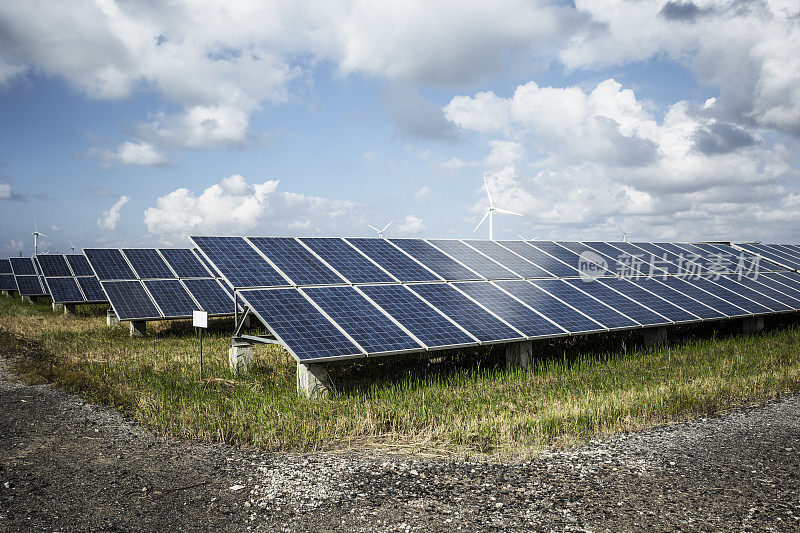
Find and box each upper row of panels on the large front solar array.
[192,237,784,289]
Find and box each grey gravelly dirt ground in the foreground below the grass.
[0,358,800,532]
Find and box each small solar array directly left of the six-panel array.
[36,254,108,304]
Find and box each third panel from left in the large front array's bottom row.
[359,285,477,348]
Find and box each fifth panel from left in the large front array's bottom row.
[455,281,566,337]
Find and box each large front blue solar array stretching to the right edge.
[192,236,800,362]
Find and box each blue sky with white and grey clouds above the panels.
[0,0,800,256]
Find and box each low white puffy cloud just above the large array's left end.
[144,174,364,244]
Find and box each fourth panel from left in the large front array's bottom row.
[409,283,522,342]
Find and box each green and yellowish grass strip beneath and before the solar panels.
[0,297,800,456]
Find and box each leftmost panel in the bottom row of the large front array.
[240,289,363,361]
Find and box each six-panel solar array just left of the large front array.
[84,248,234,320]
